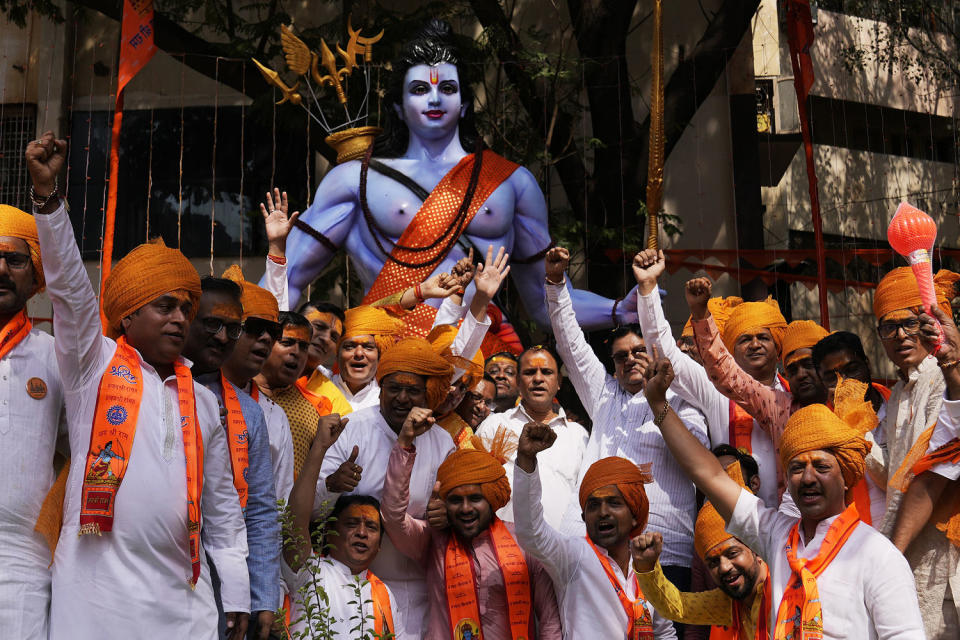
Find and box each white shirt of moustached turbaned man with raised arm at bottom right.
[727,490,926,640]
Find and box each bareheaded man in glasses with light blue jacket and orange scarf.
[183,277,283,640]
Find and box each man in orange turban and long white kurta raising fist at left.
[27,133,250,640]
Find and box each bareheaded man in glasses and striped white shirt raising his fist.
[545,247,709,608]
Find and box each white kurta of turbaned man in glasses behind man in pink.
[314,407,454,637]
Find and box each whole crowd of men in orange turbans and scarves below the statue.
[0,133,960,640]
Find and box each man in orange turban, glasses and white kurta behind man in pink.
[314,338,454,637]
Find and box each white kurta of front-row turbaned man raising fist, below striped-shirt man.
[513,462,677,640]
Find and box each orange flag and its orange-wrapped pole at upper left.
[100,0,157,327]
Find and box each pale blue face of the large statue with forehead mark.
[396,62,464,140]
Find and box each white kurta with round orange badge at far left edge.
[0,329,66,640]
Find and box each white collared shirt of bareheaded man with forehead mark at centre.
[477,403,589,528]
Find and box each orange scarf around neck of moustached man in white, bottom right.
[774,504,860,640]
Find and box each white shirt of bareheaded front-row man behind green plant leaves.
[283,556,406,640]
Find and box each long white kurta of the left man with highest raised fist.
[37,202,250,640]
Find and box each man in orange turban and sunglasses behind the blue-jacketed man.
[221,265,296,500]
